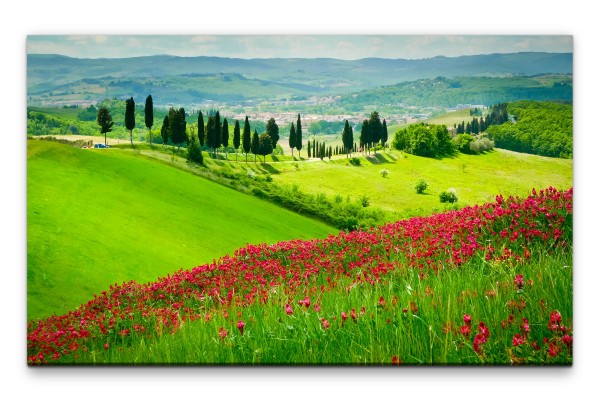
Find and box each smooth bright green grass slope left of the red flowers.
[27,140,337,320]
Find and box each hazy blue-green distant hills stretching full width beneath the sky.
[27,53,573,105]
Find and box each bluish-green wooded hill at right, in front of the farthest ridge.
[341,74,573,110]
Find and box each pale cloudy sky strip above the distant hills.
[27,35,573,60]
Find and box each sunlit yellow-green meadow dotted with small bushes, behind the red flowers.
[272,149,573,214]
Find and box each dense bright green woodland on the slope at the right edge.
[487,101,573,158]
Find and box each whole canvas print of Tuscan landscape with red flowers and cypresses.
[26,35,574,366]
